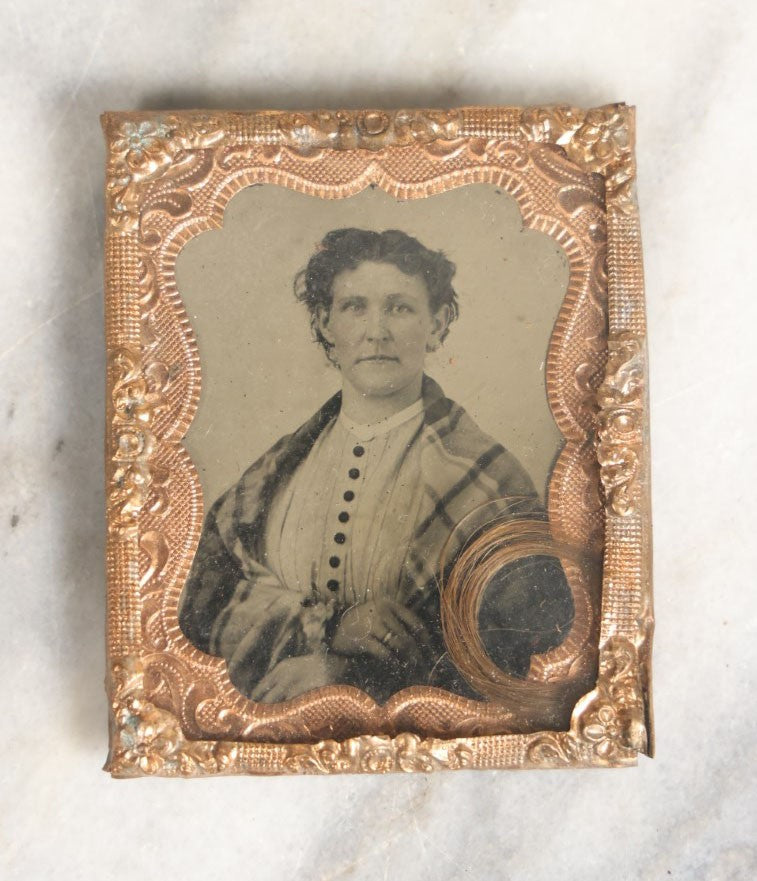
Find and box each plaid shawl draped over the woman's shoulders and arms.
[179,376,564,699]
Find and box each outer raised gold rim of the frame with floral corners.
[103,104,652,777]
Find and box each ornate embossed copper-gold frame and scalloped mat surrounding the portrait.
[103,104,653,777]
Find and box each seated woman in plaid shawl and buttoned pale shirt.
[179,228,573,703]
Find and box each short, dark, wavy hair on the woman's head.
[294,228,459,364]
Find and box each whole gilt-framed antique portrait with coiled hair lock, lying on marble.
[103,105,652,777]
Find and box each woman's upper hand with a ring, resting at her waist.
[331,599,430,666]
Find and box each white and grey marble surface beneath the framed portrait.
[0,0,757,881]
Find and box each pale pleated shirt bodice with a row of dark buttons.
[265,400,423,606]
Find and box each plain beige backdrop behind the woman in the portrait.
[176,184,568,507]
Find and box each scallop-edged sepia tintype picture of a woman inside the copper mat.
[177,184,575,703]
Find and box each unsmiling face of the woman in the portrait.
[319,261,449,397]
